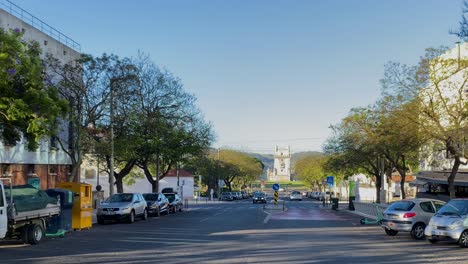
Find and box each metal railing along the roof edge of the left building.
[0,0,81,51]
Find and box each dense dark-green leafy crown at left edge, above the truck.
[0,29,67,150]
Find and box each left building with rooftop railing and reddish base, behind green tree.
[0,0,80,189]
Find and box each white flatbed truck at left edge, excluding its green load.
[0,179,60,244]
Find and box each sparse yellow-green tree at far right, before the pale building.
[383,48,468,198]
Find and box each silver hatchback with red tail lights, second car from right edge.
[382,198,445,239]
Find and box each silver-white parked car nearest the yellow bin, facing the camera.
[96,193,148,224]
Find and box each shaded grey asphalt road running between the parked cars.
[0,196,468,264]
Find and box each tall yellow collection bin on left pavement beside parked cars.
[57,182,93,229]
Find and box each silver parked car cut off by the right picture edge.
[424,199,468,247]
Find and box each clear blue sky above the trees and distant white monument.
[9,0,462,152]
